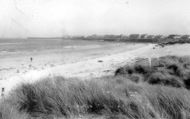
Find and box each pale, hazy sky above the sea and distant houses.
[0,0,190,37]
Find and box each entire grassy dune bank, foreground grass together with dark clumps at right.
[0,56,190,119]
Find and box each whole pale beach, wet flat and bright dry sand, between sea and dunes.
[0,39,152,94]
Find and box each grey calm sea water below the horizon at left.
[0,39,102,52]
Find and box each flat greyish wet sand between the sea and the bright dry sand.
[0,41,145,80]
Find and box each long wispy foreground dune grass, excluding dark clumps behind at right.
[0,76,190,119]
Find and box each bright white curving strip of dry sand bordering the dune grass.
[0,45,154,95]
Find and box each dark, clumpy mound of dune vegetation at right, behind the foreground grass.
[115,56,190,89]
